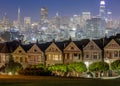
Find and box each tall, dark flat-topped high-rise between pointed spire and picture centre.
[40,7,48,24]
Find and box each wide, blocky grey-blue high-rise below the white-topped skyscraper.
[86,18,105,39]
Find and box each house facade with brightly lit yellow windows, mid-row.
[45,42,63,65]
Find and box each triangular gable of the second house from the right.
[83,41,101,51]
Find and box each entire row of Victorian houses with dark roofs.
[0,37,120,67]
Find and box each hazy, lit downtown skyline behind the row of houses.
[0,0,120,44]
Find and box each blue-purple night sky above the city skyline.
[0,0,120,21]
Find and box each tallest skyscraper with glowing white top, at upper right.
[99,0,106,19]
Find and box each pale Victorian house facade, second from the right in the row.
[83,40,102,64]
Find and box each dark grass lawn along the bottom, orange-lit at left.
[0,75,120,86]
